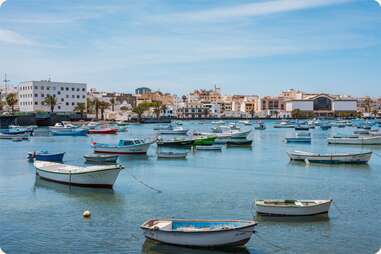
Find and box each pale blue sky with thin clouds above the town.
[0,0,381,96]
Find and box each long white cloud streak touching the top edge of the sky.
[171,0,352,21]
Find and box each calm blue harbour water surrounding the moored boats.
[0,121,381,254]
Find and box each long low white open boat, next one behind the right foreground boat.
[288,151,372,164]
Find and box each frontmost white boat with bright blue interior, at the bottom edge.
[140,219,257,247]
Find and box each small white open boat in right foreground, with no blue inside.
[255,199,332,216]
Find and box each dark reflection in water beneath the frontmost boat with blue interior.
[142,239,250,254]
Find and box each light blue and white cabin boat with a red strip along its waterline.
[91,139,152,154]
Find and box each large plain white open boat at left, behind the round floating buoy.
[34,161,122,188]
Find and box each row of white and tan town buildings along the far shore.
[0,75,381,120]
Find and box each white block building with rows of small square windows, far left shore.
[18,80,87,112]
